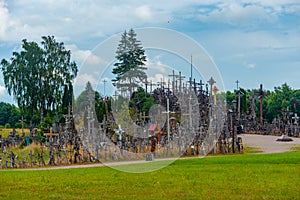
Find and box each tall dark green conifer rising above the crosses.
[112,29,147,96]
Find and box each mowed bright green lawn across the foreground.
[0,152,300,199]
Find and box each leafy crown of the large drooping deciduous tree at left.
[1,36,78,115]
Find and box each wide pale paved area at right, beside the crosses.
[241,134,300,153]
